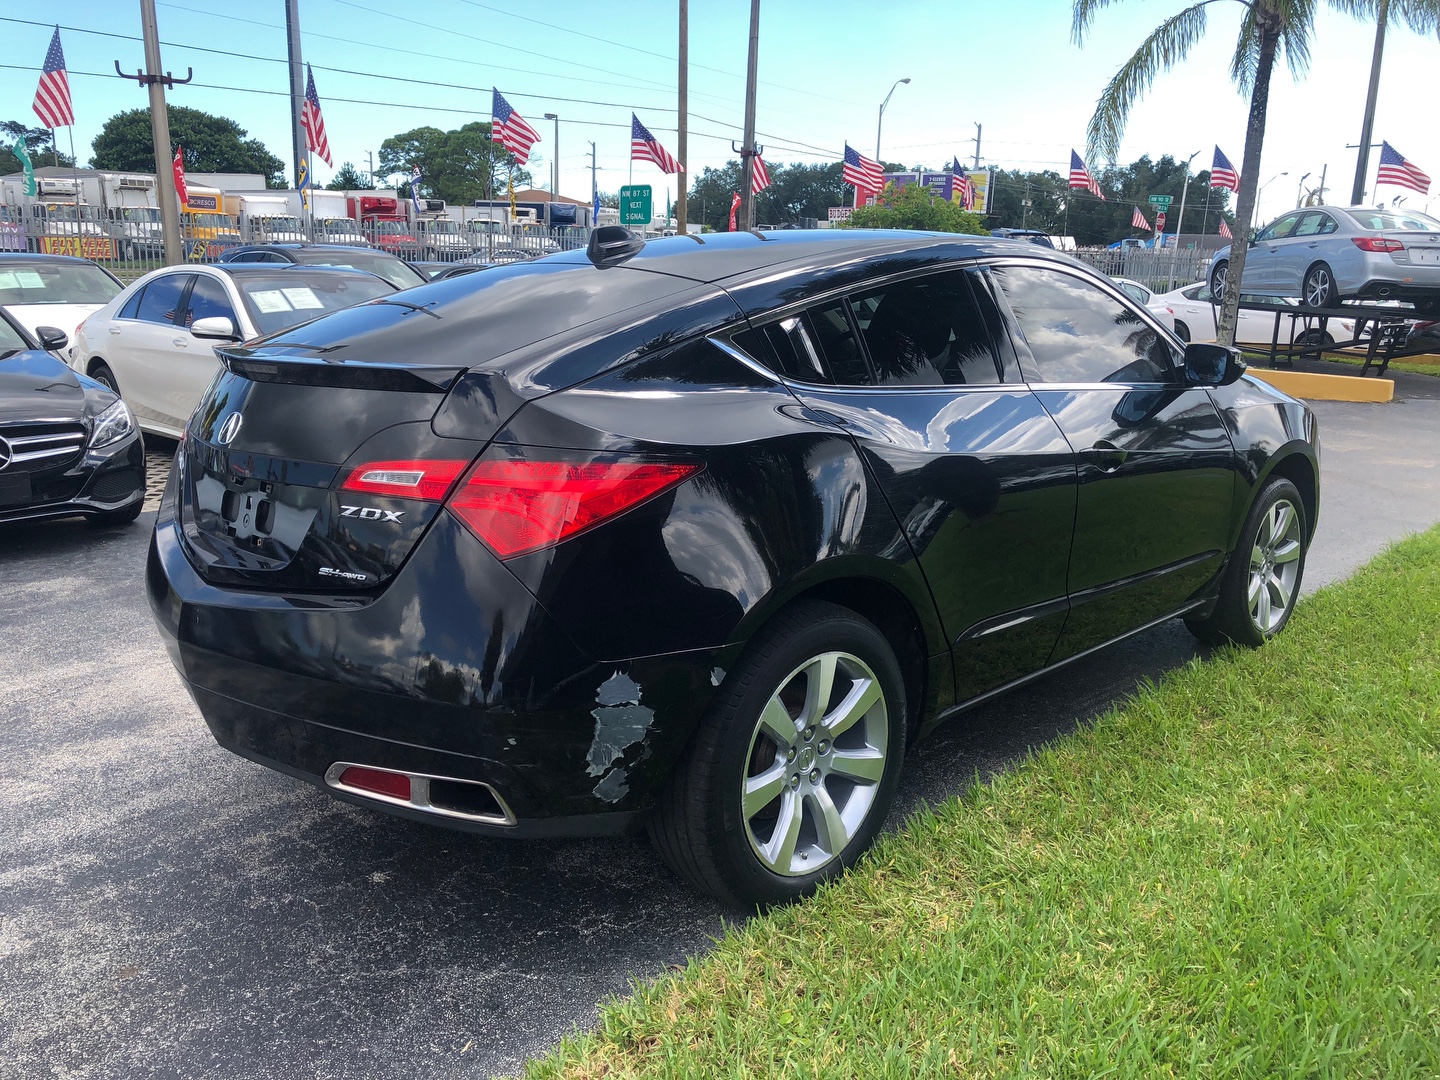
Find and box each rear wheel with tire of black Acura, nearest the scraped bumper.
[649,602,906,907]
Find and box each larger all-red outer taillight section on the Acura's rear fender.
[448,461,700,559]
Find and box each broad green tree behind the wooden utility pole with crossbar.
[91,105,287,187]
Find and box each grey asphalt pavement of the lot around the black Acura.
[0,396,1440,1080]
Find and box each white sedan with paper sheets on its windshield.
[69,262,396,439]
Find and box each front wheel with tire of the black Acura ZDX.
[1185,478,1309,648]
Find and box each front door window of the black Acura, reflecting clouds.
[992,266,1175,383]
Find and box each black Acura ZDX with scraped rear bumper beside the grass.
[147,229,1319,904]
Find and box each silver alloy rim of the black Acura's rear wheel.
[740,652,890,877]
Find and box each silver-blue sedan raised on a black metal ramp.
[1207,206,1440,314]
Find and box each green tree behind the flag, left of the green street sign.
[380,121,531,203]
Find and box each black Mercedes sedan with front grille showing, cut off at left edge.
[0,311,145,526]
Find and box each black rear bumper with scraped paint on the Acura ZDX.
[147,504,714,837]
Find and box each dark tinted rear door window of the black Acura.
[851,271,999,386]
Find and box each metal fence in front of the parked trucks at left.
[0,204,590,282]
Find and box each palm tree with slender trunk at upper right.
[1071,0,1440,344]
